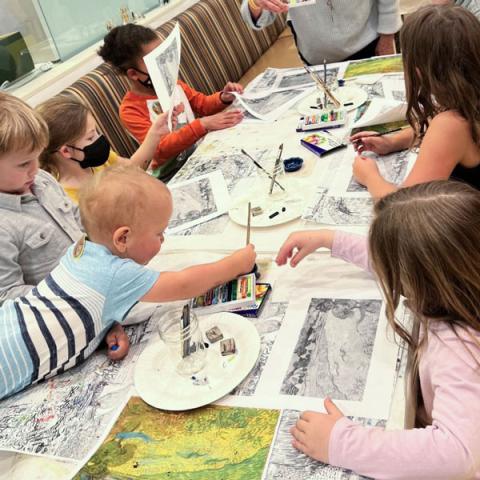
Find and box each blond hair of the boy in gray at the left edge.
[0,92,48,155]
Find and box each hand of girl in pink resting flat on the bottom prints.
[290,398,343,463]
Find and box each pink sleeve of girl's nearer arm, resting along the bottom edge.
[329,334,480,480]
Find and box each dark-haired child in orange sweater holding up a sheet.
[98,24,243,180]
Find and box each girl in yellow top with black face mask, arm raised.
[37,96,179,203]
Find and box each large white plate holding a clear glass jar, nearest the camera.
[134,312,260,411]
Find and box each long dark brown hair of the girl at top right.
[400,5,480,144]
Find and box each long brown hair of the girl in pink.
[369,181,480,424]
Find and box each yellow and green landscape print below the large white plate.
[75,397,280,480]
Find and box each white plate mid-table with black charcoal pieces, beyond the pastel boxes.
[228,175,305,228]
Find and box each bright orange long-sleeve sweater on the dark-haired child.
[120,81,227,168]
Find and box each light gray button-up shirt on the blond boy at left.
[0,170,83,304]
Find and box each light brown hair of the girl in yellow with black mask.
[36,95,90,180]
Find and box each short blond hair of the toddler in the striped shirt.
[79,165,170,239]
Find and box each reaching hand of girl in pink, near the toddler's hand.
[275,230,334,267]
